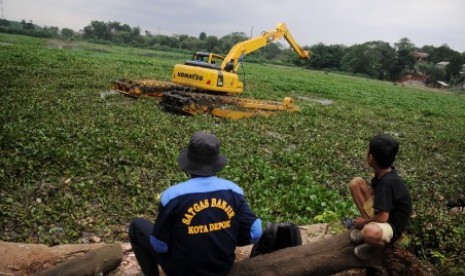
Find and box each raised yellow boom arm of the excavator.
[221,23,310,72]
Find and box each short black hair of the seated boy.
[368,134,399,169]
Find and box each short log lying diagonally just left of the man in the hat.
[39,244,123,276]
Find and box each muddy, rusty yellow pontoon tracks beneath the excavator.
[114,79,299,119]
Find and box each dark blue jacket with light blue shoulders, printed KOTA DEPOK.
[152,176,261,275]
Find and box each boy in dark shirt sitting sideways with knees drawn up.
[349,134,412,260]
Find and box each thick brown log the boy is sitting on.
[230,231,432,276]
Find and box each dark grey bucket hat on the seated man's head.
[178,131,227,176]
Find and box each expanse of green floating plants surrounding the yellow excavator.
[0,34,465,274]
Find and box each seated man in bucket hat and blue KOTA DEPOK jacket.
[129,131,262,276]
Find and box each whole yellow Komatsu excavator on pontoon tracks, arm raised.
[114,23,310,119]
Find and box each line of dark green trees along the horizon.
[0,19,465,85]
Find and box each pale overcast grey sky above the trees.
[0,0,465,52]
